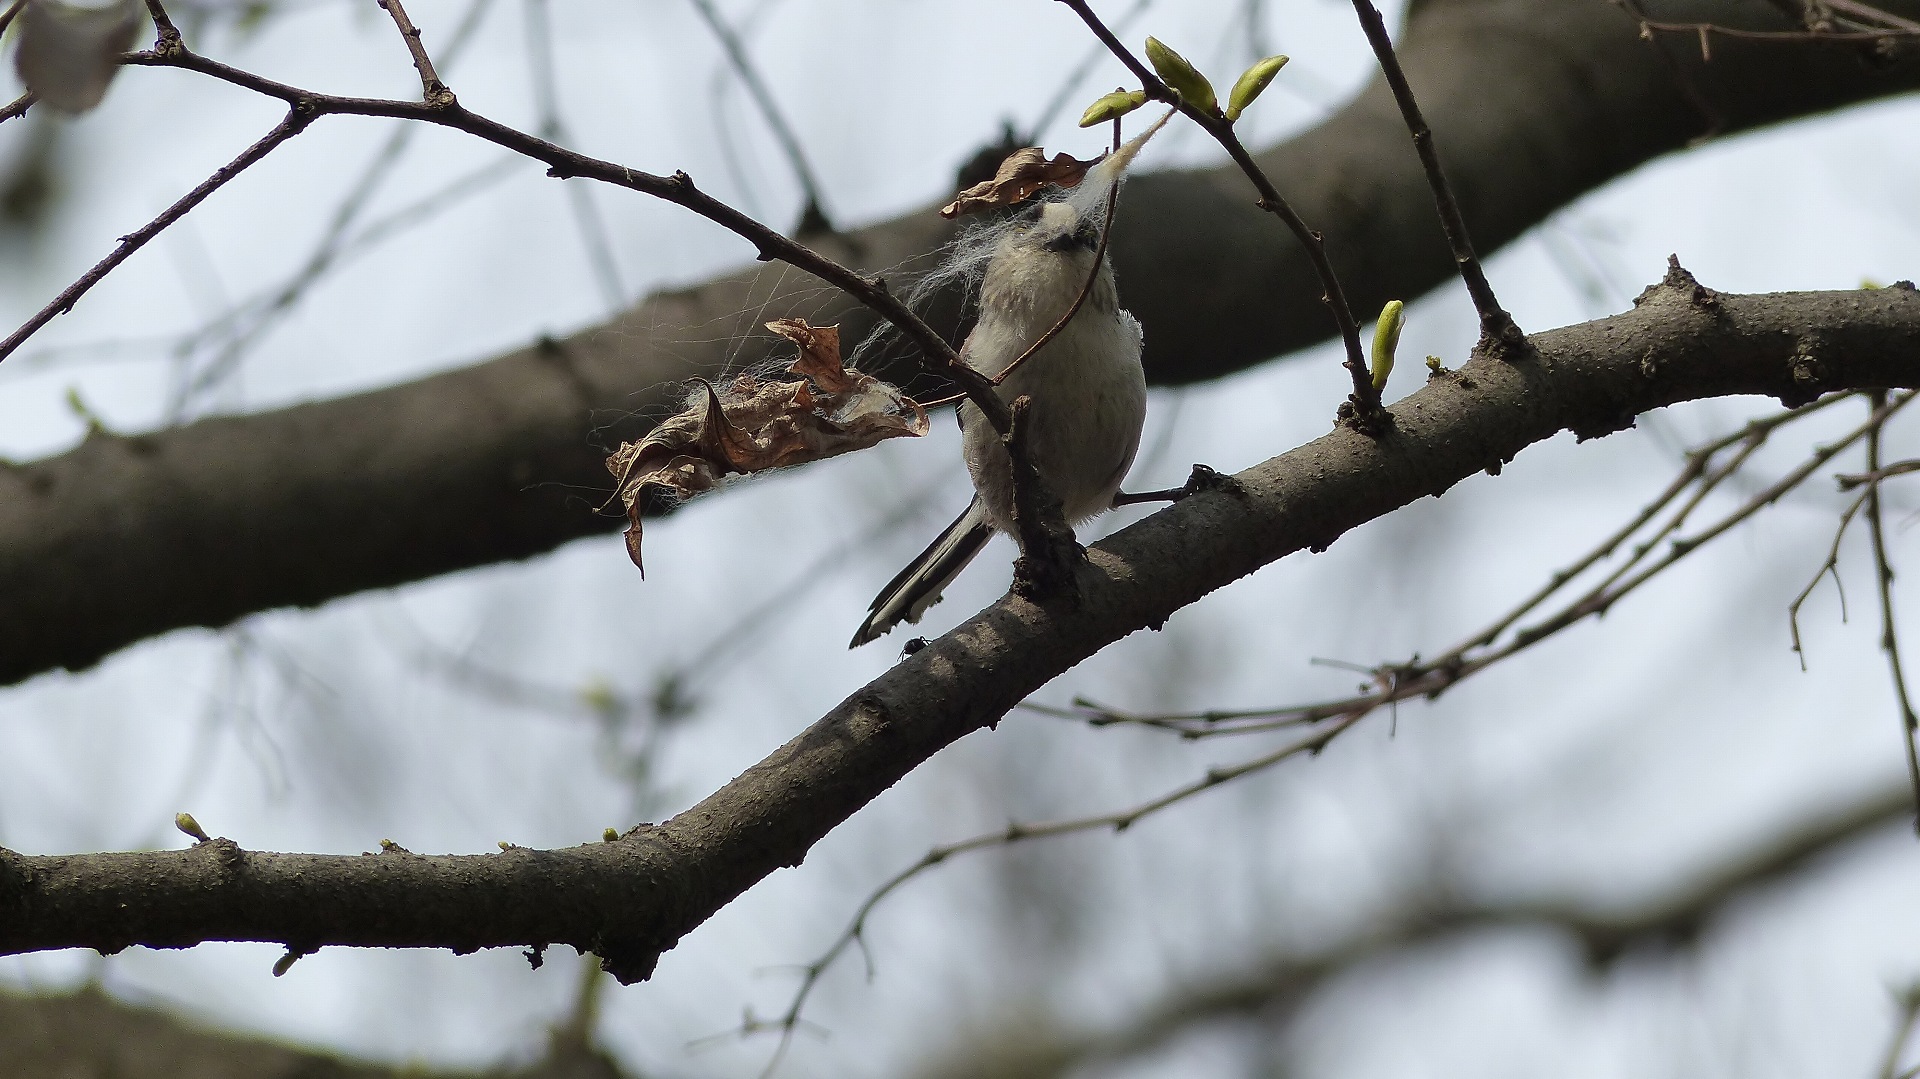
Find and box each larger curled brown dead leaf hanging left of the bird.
[607,319,927,574]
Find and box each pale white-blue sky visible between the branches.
[0,0,1920,1077]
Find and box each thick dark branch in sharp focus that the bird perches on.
[0,282,1920,981]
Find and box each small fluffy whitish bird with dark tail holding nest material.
[849,194,1146,647]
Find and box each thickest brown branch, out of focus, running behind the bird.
[0,0,1920,683]
